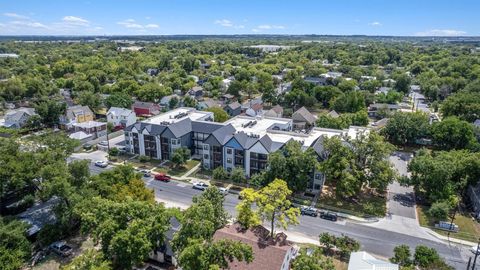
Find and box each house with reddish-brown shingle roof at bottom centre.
[213,223,299,270]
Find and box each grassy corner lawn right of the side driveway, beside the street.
[417,205,480,242]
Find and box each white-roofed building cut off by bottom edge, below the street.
[348,251,399,270]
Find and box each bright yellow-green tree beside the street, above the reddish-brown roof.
[256,179,300,238]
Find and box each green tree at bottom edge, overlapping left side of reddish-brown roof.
[178,239,253,270]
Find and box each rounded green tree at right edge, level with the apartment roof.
[432,117,478,150]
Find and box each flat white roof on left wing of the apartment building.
[142,107,213,125]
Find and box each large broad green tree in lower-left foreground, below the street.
[79,198,169,269]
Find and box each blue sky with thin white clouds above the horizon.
[0,0,480,36]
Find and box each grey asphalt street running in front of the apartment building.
[144,178,472,269]
